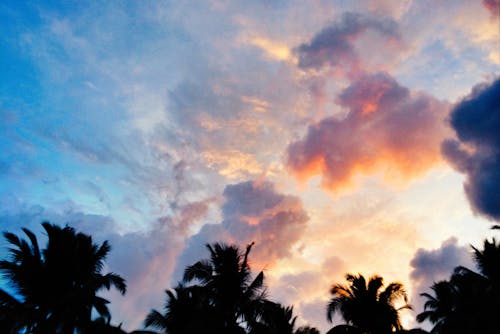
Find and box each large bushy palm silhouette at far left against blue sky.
[0,222,126,333]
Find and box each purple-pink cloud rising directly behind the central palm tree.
[176,180,309,278]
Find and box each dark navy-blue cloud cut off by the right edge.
[442,79,500,221]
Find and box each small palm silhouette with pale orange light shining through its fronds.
[327,274,410,334]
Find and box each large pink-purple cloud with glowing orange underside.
[286,73,447,191]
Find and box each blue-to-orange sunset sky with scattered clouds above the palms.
[0,0,500,330]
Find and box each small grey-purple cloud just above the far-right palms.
[410,237,473,326]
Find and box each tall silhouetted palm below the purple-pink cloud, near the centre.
[184,243,265,333]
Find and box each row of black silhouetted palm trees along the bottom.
[0,222,500,334]
